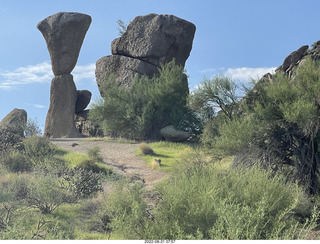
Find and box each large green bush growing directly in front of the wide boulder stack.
[90,61,198,139]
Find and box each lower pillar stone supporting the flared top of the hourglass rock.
[44,75,82,138]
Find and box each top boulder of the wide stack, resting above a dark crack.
[111,14,196,66]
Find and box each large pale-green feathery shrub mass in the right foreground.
[105,154,318,240]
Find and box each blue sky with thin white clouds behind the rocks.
[0,0,320,132]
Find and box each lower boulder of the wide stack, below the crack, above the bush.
[95,55,158,96]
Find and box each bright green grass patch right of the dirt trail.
[136,141,195,172]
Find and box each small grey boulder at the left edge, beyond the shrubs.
[0,108,27,137]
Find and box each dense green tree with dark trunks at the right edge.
[216,59,320,193]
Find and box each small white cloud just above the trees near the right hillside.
[224,67,276,81]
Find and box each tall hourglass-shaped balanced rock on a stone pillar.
[37,12,91,138]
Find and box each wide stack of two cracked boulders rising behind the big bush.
[96,14,196,97]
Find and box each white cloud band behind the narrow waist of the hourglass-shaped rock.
[0,62,95,90]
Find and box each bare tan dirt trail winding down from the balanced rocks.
[50,138,168,189]
